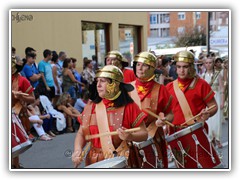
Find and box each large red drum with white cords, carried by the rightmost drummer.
[166,123,223,168]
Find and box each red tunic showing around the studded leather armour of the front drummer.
[78,99,147,148]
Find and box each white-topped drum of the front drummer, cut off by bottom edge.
[85,156,127,168]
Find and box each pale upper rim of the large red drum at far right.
[165,123,203,142]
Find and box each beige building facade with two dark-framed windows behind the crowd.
[11,11,148,70]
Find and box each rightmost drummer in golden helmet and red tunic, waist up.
[163,51,217,128]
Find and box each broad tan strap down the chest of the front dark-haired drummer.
[96,101,115,159]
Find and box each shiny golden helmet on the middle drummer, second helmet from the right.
[134,51,157,68]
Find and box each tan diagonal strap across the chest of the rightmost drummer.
[173,78,195,125]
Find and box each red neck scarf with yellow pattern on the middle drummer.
[136,79,154,101]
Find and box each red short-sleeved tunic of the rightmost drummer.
[166,77,214,125]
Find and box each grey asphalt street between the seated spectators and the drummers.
[20,121,230,169]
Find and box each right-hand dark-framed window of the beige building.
[119,25,141,66]
